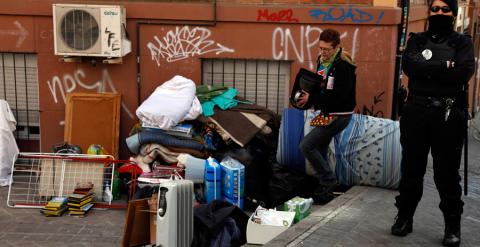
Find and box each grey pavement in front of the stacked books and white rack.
[0,187,127,247]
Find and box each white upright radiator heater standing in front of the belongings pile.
[156,180,195,247]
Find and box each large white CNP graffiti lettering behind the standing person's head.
[272,25,358,69]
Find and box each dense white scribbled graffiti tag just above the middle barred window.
[147,26,235,66]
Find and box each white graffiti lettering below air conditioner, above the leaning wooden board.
[47,69,133,119]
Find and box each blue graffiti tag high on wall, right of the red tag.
[309,6,384,23]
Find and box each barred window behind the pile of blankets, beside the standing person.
[202,59,290,114]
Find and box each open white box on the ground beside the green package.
[247,211,295,244]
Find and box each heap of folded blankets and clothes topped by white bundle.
[126,75,276,172]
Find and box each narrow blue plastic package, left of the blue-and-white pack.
[205,157,222,203]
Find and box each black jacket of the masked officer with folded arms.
[402,32,475,97]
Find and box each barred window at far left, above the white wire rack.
[0,53,40,140]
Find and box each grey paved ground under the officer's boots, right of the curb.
[265,130,480,247]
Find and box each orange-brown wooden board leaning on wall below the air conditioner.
[64,92,121,158]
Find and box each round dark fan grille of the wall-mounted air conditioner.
[61,9,99,50]
